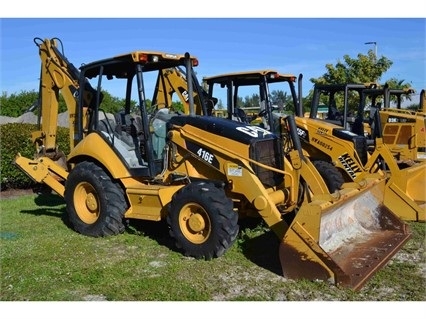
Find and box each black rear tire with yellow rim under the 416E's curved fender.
[64,162,127,237]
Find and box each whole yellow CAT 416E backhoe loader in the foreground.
[15,38,411,290]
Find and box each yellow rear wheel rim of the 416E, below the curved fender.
[74,182,99,224]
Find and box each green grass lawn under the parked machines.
[0,194,426,304]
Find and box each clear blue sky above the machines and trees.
[0,1,426,107]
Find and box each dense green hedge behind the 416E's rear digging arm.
[0,123,69,190]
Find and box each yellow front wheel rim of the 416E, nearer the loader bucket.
[179,203,211,244]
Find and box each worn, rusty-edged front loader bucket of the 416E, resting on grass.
[279,180,411,291]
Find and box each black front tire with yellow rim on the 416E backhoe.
[167,182,239,260]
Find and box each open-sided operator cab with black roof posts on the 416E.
[77,51,210,180]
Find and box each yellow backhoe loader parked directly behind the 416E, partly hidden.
[203,70,426,221]
